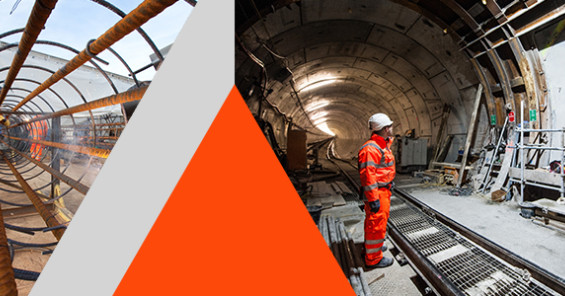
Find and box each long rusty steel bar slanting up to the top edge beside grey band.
[8,0,177,111]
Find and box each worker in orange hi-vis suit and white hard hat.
[359,113,396,268]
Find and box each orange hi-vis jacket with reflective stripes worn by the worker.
[359,134,396,202]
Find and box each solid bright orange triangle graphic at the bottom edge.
[114,87,355,296]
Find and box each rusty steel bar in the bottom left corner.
[0,207,18,296]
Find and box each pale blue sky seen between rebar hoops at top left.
[0,0,193,80]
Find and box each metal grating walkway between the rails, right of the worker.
[389,196,559,296]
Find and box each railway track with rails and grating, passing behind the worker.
[322,142,565,296]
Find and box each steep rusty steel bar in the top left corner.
[0,0,57,105]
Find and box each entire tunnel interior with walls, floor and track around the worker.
[234,0,565,295]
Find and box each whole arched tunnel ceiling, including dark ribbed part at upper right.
[236,0,562,157]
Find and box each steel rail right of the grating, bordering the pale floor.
[393,188,565,295]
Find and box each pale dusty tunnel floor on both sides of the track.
[316,174,565,295]
